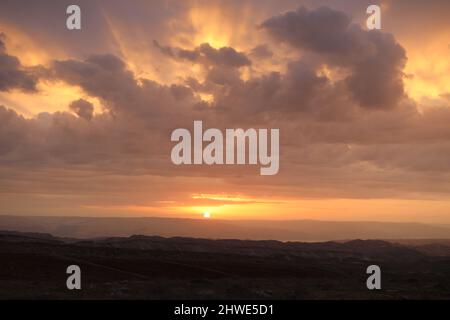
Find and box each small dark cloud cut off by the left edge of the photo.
[0,34,37,92]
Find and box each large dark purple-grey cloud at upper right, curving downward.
[261,7,406,109]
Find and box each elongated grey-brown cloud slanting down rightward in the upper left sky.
[53,54,204,125]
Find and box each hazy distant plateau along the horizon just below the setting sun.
[0,216,450,241]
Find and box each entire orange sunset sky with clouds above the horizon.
[0,0,450,223]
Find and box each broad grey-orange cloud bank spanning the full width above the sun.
[0,2,450,211]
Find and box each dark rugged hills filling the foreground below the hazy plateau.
[0,231,450,299]
